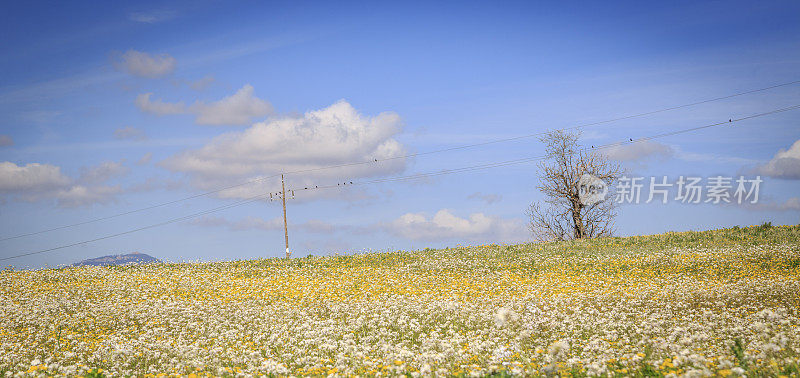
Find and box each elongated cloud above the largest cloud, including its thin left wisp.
[136,84,273,126]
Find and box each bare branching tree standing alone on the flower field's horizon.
[527,130,622,240]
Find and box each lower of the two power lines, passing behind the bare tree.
[0,104,800,261]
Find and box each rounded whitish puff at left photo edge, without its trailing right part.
[0,161,70,193]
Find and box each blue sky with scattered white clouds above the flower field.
[0,1,800,267]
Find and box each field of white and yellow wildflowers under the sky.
[0,226,800,376]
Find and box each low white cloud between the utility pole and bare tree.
[383,209,525,241]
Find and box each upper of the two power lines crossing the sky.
[0,80,800,242]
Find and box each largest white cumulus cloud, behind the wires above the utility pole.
[160,100,406,198]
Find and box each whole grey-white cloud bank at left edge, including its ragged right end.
[0,161,127,207]
